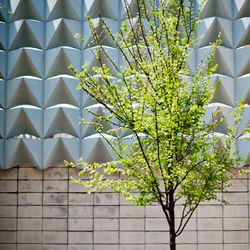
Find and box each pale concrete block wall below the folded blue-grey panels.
[0,167,250,250]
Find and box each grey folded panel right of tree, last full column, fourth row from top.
[212,75,234,107]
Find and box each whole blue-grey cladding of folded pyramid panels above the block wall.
[0,0,250,168]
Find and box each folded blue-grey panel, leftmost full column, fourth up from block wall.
[9,49,42,79]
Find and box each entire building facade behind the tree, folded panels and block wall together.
[0,0,250,250]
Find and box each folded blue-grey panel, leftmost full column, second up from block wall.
[6,108,42,138]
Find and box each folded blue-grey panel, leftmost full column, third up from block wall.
[7,78,42,108]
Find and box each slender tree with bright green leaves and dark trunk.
[68,0,249,250]
